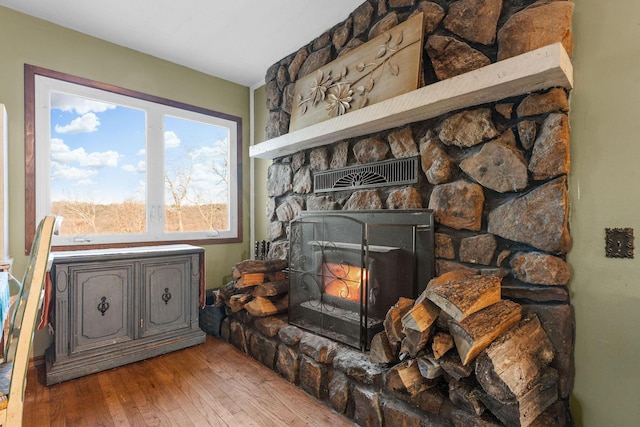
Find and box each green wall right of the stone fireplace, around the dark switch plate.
[568,0,640,426]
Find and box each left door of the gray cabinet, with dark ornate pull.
[69,263,134,353]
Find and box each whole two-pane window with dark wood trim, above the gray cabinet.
[25,65,242,250]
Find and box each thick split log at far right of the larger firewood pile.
[476,315,553,401]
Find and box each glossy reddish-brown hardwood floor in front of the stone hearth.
[23,336,355,427]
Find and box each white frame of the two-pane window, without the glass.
[25,64,242,249]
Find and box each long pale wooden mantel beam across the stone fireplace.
[249,43,573,159]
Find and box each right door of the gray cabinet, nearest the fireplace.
[141,256,191,337]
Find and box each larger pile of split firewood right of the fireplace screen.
[370,272,558,426]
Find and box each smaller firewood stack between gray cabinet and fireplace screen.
[215,259,289,317]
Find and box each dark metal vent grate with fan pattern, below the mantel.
[313,157,418,193]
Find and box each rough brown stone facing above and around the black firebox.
[258,0,574,425]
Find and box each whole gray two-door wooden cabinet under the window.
[45,245,206,385]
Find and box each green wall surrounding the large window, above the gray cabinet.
[0,7,250,357]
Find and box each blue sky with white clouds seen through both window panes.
[50,92,228,204]
